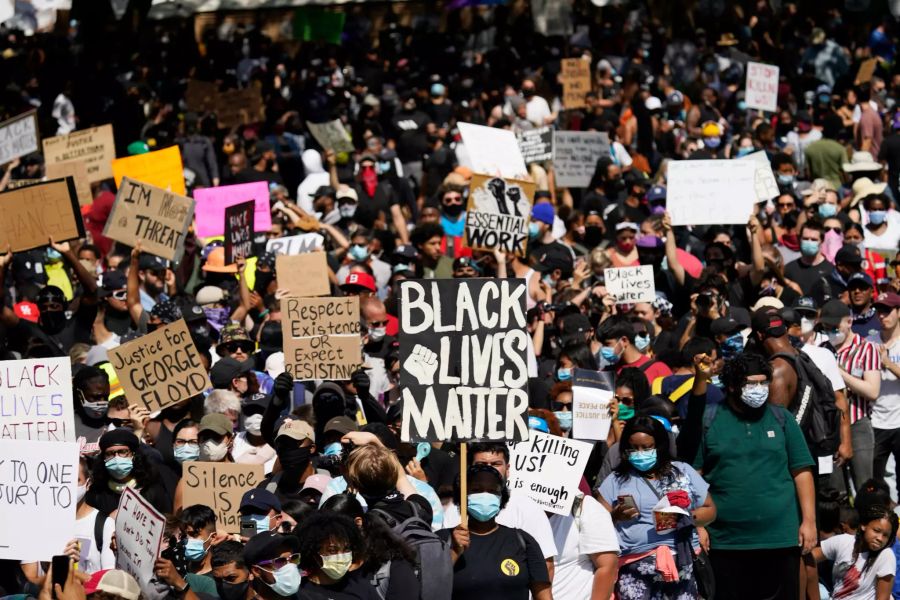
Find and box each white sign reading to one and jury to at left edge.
[0,440,78,562]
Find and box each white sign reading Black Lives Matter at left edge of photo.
[0,358,75,442]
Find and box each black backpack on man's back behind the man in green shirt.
[771,352,841,456]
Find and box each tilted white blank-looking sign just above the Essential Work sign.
[458,123,528,178]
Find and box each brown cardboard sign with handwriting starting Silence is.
[181,462,266,533]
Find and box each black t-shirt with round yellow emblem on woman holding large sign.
[438,525,550,600]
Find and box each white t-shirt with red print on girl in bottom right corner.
[822,533,897,600]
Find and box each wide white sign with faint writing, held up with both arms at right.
[666,160,756,225]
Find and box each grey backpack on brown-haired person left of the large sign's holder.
[368,502,453,600]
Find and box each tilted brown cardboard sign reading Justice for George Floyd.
[108,319,212,412]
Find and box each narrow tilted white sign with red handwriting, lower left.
[116,487,166,589]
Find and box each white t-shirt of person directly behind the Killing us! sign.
[550,496,619,600]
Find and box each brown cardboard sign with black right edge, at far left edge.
[0,177,84,252]
